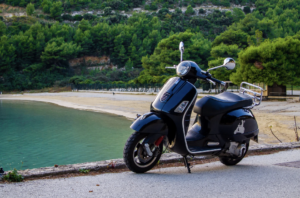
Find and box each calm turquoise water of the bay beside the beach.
[0,100,132,171]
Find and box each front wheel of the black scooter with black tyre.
[123,132,163,173]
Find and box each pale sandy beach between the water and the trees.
[0,92,300,144]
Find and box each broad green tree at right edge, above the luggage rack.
[230,37,300,86]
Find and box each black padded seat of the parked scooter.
[194,92,252,117]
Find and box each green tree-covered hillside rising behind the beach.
[0,0,299,90]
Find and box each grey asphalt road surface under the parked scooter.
[0,149,300,198]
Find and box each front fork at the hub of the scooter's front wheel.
[142,133,165,157]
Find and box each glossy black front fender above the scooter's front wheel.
[130,113,168,135]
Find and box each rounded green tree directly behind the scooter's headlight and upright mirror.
[137,32,211,83]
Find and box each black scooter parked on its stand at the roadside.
[123,42,263,173]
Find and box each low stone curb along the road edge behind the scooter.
[5,142,300,178]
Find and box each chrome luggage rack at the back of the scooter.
[239,82,263,109]
